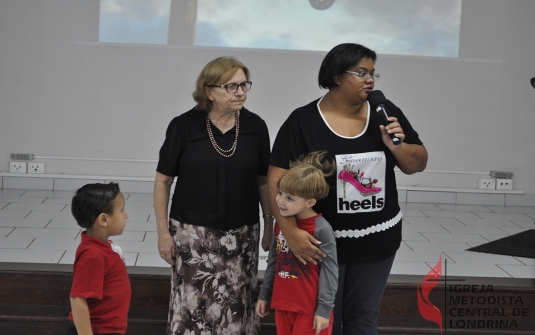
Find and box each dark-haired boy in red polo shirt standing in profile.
[67,183,131,335]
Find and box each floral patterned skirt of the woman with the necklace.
[167,219,260,335]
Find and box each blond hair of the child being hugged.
[277,151,336,200]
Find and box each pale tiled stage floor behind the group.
[0,189,535,278]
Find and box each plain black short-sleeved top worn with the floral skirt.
[156,108,270,229]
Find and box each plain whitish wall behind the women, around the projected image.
[0,0,535,194]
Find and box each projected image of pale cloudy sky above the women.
[100,0,461,57]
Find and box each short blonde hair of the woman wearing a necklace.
[192,57,250,111]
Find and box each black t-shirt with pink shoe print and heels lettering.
[270,99,422,263]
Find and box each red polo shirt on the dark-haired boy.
[69,232,131,334]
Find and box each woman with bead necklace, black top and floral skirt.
[154,57,273,334]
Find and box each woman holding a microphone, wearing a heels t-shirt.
[268,43,427,335]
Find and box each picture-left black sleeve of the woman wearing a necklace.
[156,117,182,177]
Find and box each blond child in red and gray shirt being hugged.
[256,152,338,335]
